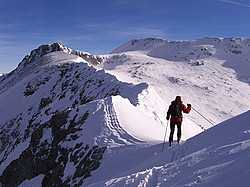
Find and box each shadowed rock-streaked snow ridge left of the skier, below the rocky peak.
[0,47,167,186]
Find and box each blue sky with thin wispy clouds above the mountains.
[0,0,250,73]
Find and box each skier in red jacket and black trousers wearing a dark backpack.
[167,96,191,147]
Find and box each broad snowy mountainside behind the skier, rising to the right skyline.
[101,38,250,130]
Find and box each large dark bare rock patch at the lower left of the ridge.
[0,111,106,187]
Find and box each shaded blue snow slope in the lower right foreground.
[89,111,250,187]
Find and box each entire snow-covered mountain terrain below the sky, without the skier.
[0,38,250,187]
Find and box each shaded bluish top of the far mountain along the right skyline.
[112,37,250,83]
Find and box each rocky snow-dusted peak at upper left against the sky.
[0,43,103,93]
